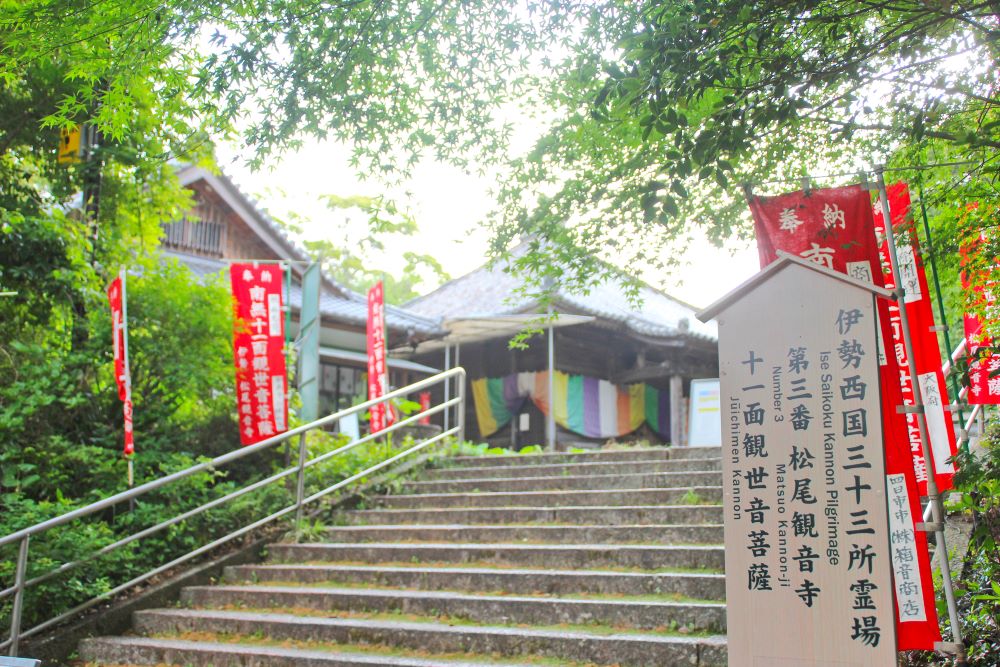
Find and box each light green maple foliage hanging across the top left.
[0,0,542,173]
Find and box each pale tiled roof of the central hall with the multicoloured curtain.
[406,244,718,340]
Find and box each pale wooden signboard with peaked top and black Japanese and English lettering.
[699,257,896,667]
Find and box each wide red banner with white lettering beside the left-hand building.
[230,263,288,445]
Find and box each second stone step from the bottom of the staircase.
[135,609,726,667]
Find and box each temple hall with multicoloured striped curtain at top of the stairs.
[397,244,718,448]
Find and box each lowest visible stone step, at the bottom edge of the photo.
[80,637,575,667]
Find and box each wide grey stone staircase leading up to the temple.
[80,448,726,667]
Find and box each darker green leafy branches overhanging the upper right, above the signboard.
[493,0,1000,306]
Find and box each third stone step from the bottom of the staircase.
[181,585,726,632]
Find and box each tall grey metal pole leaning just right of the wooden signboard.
[875,165,966,665]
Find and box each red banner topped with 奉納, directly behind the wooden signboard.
[750,185,941,650]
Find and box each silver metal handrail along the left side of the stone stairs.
[0,367,466,656]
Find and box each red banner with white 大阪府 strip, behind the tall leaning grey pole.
[874,182,957,494]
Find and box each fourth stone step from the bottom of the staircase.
[224,564,726,600]
